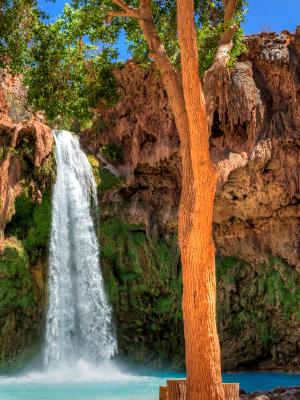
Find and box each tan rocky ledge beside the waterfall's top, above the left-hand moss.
[0,71,53,252]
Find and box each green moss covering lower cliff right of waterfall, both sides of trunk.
[92,160,300,370]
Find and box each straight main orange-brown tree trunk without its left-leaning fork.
[177,0,225,400]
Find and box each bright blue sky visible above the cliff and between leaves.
[38,0,300,60]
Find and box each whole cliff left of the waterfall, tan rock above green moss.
[0,71,55,370]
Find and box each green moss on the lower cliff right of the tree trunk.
[216,257,300,367]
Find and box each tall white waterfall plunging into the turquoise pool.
[44,131,117,367]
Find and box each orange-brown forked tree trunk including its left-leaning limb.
[111,0,234,400]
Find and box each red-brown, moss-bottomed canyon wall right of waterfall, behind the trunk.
[81,29,300,369]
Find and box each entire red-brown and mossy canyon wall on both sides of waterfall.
[0,31,300,370]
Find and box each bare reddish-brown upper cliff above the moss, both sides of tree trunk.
[82,33,300,268]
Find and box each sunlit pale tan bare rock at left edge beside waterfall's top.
[0,75,53,251]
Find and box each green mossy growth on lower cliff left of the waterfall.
[0,187,51,371]
